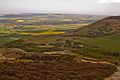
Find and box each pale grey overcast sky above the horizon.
[0,0,120,15]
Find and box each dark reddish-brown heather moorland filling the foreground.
[0,61,116,80]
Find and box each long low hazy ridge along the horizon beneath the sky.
[0,13,105,19]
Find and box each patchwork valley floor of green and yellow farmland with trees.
[0,15,120,59]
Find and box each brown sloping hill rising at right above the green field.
[72,16,120,37]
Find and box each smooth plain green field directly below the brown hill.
[80,34,120,51]
